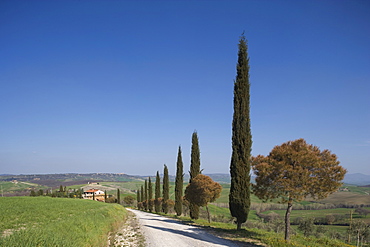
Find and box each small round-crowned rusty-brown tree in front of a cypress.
[185,174,222,223]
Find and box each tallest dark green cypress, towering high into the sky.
[229,33,252,230]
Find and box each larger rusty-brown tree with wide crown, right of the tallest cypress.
[252,139,346,241]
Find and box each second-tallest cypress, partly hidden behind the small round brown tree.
[189,131,201,219]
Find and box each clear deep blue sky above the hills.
[0,0,370,175]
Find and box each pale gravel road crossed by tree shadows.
[128,209,250,247]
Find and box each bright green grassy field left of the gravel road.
[0,197,126,247]
